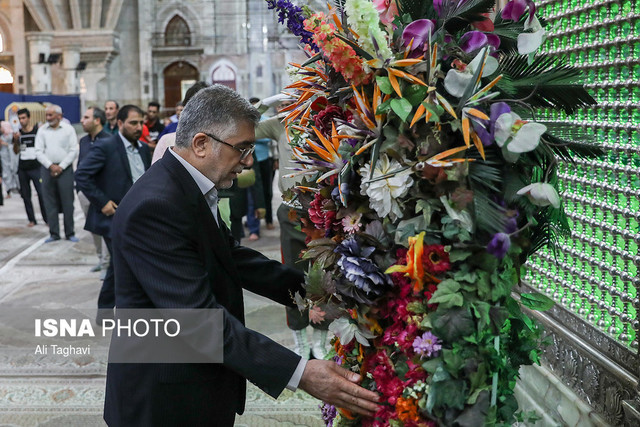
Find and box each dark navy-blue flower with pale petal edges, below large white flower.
[335,237,391,296]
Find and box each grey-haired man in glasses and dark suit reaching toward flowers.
[104,85,378,427]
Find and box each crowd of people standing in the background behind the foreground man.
[0,82,327,358]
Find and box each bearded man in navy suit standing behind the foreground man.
[75,105,151,316]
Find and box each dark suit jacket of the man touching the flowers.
[105,151,303,427]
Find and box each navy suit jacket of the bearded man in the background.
[75,135,151,236]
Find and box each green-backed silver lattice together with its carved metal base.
[525,0,640,425]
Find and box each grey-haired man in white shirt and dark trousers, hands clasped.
[36,104,79,243]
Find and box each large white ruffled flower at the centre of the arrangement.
[360,154,413,221]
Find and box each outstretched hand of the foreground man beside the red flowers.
[299,360,379,416]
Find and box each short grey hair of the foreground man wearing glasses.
[176,84,260,148]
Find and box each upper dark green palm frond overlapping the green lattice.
[496,52,596,114]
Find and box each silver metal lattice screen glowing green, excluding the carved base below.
[527,0,640,350]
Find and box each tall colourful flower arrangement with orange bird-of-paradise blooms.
[268,0,600,426]
